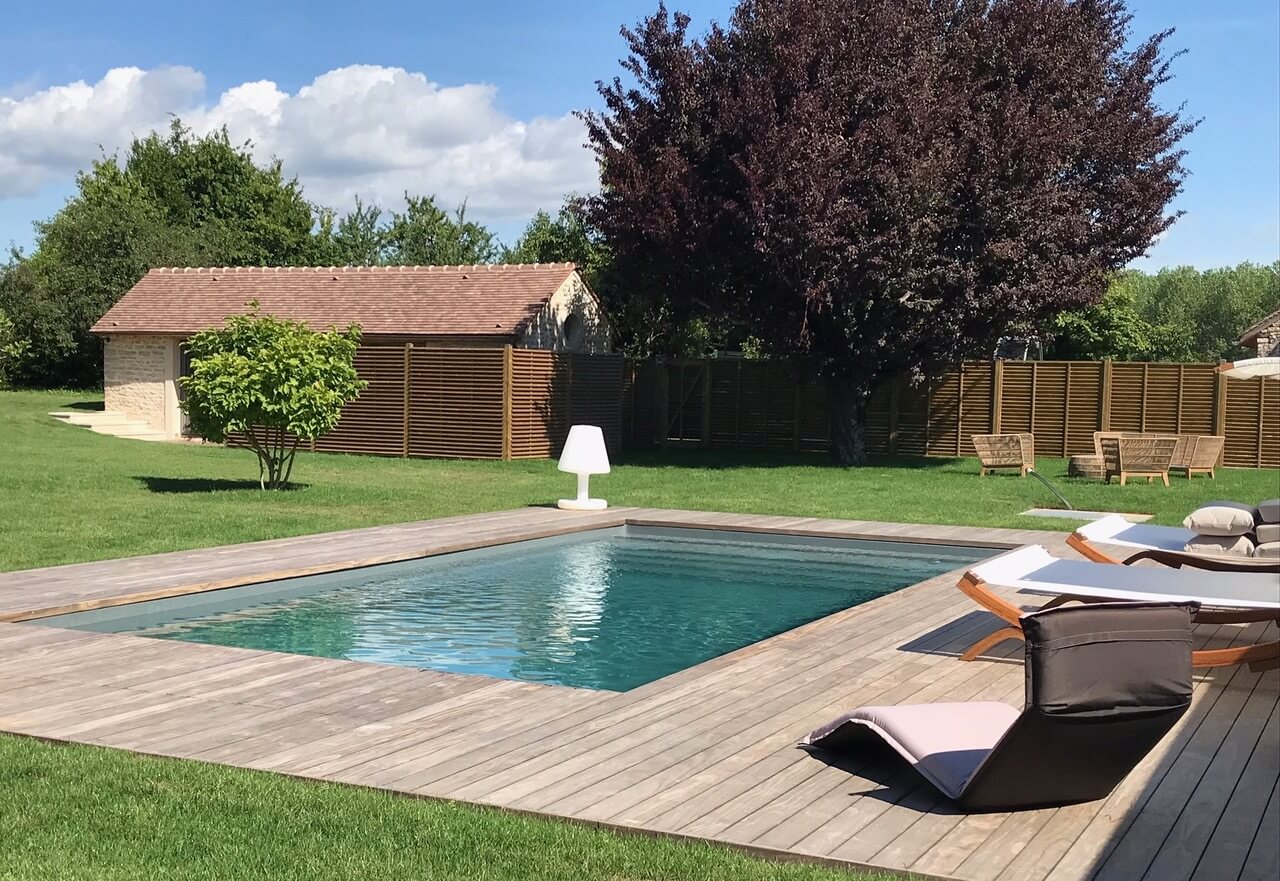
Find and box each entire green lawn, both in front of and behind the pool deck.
[0,392,1277,881]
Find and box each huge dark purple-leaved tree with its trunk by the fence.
[584,0,1194,464]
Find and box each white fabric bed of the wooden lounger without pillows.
[969,544,1280,608]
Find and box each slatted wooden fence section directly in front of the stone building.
[275,346,625,458]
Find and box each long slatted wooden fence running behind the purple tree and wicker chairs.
[622,359,1280,467]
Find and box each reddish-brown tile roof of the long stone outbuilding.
[92,263,573,335]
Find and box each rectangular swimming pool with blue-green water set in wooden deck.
[40,526,996,691]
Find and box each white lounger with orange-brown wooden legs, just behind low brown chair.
[957,544,1280,670]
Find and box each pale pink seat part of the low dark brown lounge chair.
[800,700,1020,798]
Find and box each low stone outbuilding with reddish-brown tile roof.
[93,263,611,437]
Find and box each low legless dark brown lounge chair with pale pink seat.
[801,603,1194,811]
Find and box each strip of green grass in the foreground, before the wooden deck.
[0,735,888,881]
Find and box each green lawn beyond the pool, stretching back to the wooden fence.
[0,392,1276,571]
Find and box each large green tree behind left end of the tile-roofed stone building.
[0,120,315,387]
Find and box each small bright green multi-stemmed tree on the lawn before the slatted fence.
[179,303,366,489]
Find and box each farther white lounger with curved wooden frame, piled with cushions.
[1066,513,1280,572]
